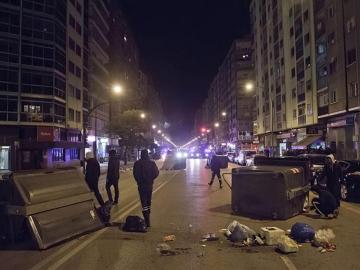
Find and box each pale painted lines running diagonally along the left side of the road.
[30,172,178,270]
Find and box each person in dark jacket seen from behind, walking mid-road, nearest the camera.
[133,150,159,227]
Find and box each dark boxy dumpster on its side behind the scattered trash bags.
[231,166,310,219]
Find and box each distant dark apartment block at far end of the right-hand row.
[194,39,255,148]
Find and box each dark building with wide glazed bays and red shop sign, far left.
[0,0,83,170]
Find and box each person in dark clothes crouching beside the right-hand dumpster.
[312,186,339,217]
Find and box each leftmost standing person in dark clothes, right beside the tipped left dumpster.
[85,152,104,206]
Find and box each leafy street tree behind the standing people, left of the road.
[108,110,151,163]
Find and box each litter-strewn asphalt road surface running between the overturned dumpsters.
[0,160,360,270]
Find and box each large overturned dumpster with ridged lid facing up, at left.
[0,169,103,249]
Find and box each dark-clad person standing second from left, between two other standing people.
[105,150,120,205]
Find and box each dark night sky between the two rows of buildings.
[119,0,249,142]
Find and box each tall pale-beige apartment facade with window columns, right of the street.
[250,0,324,155]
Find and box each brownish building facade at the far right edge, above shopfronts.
[314,0,360,159]
